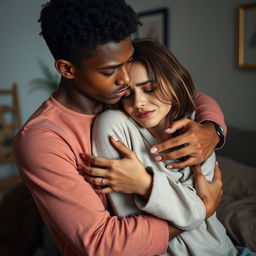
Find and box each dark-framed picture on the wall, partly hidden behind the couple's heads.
[135,8,169,47]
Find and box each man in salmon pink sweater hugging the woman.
[14,0,225,256]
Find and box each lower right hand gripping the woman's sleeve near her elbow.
[192,162,223,219]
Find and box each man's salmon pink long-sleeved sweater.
[13,94,226,256]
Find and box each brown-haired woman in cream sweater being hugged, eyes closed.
[87,40,237,256]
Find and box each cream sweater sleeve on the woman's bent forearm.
[136,153,215,230]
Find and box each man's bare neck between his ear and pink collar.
[53,80,103,115]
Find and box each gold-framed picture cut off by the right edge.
[238,3,256,69]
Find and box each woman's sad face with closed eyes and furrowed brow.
[122,62,171,134]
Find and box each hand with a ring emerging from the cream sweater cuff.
[79,137,152,199]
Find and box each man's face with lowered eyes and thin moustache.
[73,37,133,104]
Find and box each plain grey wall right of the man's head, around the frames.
[127,0,256,131]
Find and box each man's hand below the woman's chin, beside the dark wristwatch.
[150,118,219,169]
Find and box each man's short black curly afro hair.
[38,0,140,62]
